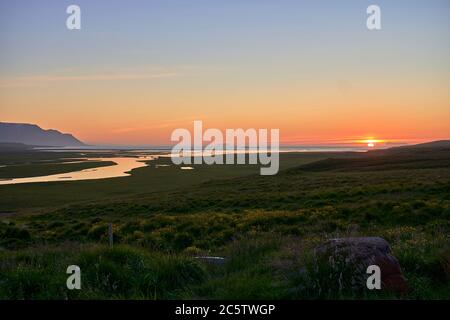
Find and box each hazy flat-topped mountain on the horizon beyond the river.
[0,122,85,147]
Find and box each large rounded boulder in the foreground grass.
[316,237,408,293]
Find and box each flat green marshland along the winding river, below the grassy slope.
[0,152,325,214]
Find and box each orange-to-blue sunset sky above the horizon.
[0,0,450,145]
